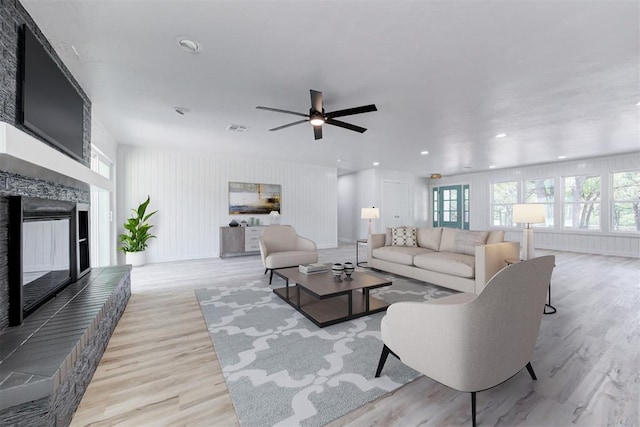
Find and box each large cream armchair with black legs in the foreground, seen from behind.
[376,256,555,426]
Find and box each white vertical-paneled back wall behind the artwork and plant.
[117,146,337,262]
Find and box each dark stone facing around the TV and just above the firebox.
[0,0,91,333]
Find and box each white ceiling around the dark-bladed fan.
[21,0,640,176]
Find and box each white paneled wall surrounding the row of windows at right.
[431,152,640,257]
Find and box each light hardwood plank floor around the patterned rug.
[71,245,640,427]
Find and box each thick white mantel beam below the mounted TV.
[0,122,114,191]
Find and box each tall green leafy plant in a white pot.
[120,196,158,267]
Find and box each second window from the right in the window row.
[564,176,600,230]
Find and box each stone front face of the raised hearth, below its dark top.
[0,274,131,426]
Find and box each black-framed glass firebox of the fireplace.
[8,196,90,326]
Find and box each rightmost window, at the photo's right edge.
[611,171,640,232]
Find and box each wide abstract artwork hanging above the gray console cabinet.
[229,182,282,215]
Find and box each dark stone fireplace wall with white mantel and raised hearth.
[0,0,131,426]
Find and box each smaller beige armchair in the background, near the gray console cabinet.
[260,225,318,284]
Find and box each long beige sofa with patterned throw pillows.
[367,227,520,294]
